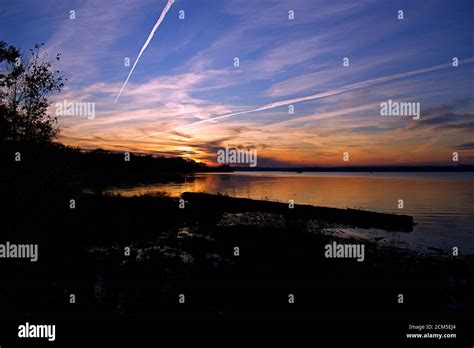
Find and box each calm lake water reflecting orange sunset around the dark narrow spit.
[108,172,474,254]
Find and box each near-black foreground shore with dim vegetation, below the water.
[0,167,474,319]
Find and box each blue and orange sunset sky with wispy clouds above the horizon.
[0,0,474,166]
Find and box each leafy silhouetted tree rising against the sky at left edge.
[0,41,64,143]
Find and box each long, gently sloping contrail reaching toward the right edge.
[133,57,474,140]
